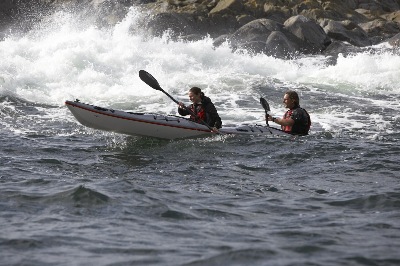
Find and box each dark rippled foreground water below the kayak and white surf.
[0,98,400,265]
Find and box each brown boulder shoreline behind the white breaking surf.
[0,0,400,58]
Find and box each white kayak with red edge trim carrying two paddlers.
[65,100,290,139]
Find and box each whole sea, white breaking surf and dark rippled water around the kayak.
[0,6,400,265]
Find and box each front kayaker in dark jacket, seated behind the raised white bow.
[178,87,222,132]
